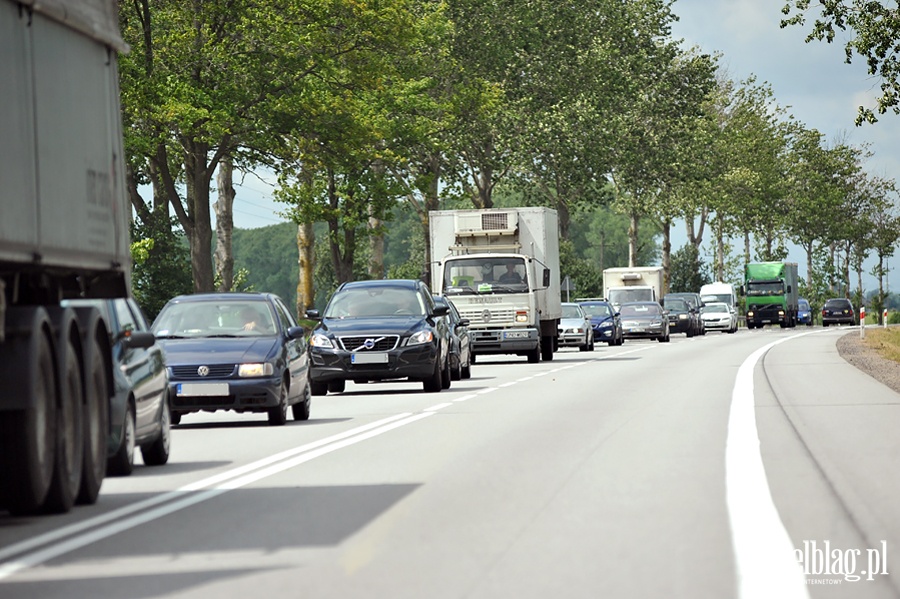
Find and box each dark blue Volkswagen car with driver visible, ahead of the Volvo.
[153,293,310,425]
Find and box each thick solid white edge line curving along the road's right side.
[725,333,809,599]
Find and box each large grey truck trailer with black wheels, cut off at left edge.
[0,0,131,514]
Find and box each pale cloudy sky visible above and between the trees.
[234,0,900,289]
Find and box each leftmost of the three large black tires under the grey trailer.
[0,307,58,516]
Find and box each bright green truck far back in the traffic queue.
[741,262,799,329]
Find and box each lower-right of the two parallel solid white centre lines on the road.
[0,413,433,580]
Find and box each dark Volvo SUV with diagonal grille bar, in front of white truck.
[306,279,451,395]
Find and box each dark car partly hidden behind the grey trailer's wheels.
[65,298,171,476]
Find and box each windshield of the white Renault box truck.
[444,256,528,295]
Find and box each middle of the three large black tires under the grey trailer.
[43,308,84,514]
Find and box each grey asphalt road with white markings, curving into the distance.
[0,328,900,599]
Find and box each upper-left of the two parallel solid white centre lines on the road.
[0,412,411,578]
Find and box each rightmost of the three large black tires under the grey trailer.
[76,308,112,505]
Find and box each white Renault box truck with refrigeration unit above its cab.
[428,208,562,362]
